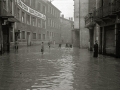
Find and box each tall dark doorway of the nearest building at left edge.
[2,25,10,52]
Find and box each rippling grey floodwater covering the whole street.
[0,46,120,90]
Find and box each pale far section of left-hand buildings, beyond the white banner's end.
[46,2,61,43]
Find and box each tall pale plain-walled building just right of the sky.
[73,0,89,48]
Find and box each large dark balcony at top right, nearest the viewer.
[94,0,120,22]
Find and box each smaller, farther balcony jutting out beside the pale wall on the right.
[85,13,95,29]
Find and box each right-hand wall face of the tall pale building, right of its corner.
[80,0,89,48]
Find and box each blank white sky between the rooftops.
[52,0,74,18]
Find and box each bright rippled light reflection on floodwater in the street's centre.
[31,48,74,90]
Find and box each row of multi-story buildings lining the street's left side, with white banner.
[0,0,61,54]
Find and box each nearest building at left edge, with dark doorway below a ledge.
[0,0,19,53]
